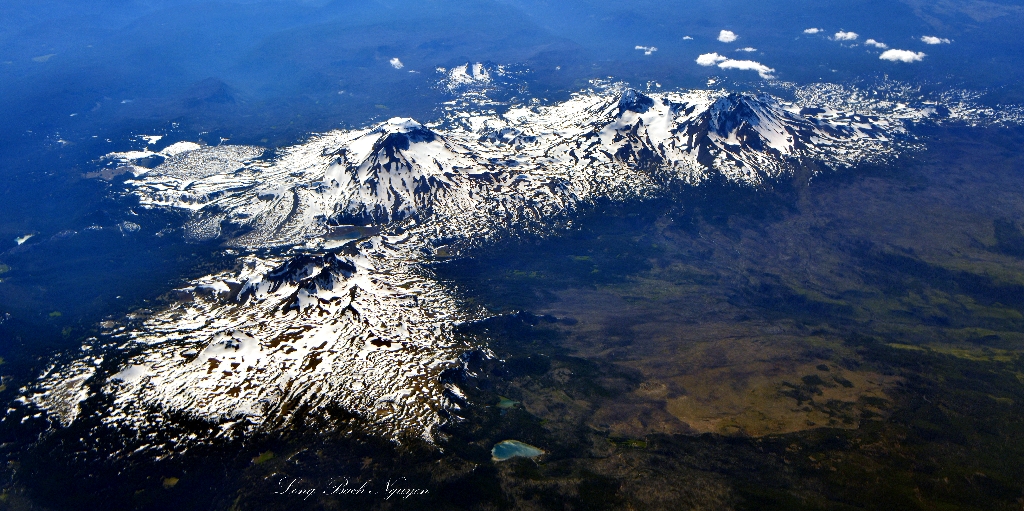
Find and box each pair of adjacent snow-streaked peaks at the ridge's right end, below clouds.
[581,89,901,184]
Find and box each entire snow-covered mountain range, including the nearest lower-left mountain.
[23,71,1015,452]
